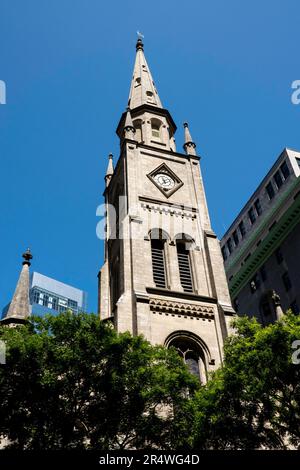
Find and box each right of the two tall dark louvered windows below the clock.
[176,235,194,292]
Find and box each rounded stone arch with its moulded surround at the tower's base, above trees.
[165,331,211,384]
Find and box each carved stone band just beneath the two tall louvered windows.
[149,298,214,319]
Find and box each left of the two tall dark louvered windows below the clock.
[150,229,167,288]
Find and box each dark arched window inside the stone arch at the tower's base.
[166,332,207,384]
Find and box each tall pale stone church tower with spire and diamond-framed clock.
[99,39,234,382]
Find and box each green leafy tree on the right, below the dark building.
[191,312,300,449]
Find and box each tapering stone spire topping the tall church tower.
[128,38,162,109]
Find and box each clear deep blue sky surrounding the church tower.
[0,0,300,311]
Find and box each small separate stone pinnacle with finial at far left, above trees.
[1,248,32,325]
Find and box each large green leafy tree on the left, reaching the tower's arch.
[0,313,198,450]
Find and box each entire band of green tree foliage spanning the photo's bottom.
[0,313,300,450]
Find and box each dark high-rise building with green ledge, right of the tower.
[221,148,300,324]
